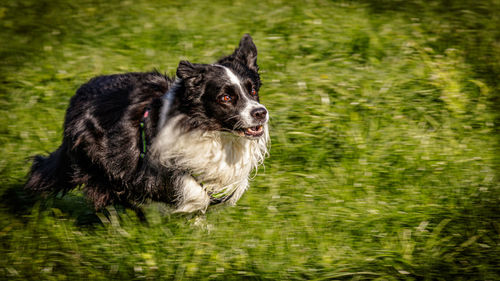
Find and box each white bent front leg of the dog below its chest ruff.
[174,175,210,213]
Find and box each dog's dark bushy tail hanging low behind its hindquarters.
[24,143,71,194]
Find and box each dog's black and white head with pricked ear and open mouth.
[177,34,269,138]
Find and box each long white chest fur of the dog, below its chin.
[151,116,269,208]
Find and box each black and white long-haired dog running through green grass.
[25,35,269,212]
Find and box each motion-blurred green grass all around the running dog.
[0,0,500,280]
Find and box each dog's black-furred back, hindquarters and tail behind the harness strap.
[25,72,172,207]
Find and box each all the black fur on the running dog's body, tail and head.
[25,35,260,209]
